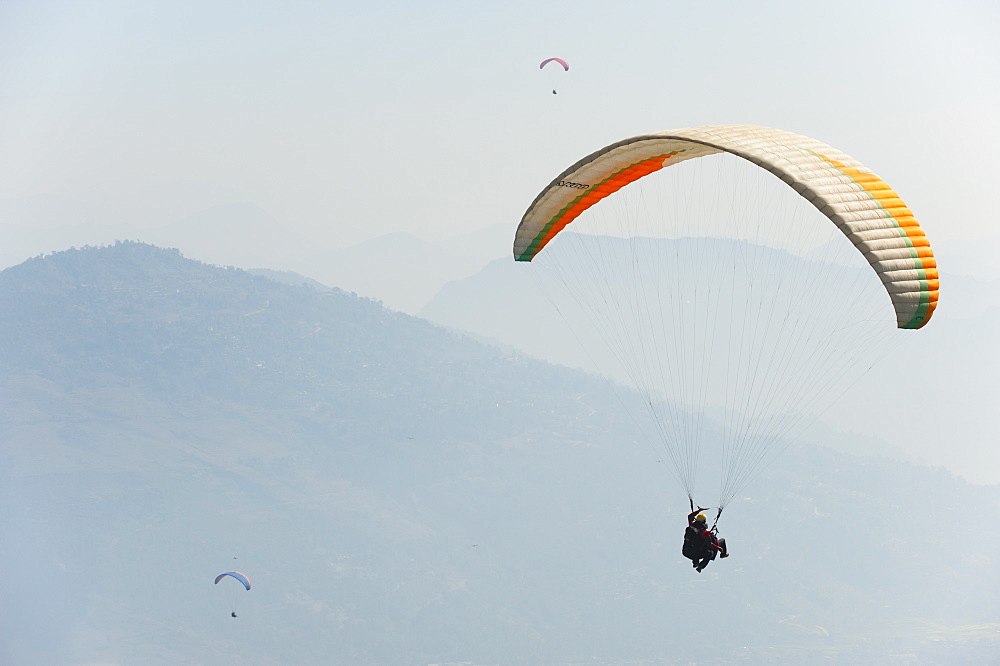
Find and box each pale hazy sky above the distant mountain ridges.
[0,0,1000,249]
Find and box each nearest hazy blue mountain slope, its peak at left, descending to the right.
[0,244,1000,664]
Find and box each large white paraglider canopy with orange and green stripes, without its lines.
[514,125,938,328]
